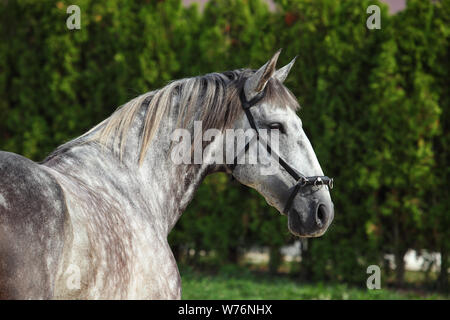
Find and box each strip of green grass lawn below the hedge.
[180,268,448,300]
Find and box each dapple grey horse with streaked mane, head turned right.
[0,52,334,299]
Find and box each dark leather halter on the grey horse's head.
[230,90,333,214]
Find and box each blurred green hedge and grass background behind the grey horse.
[0,0,450,299]
